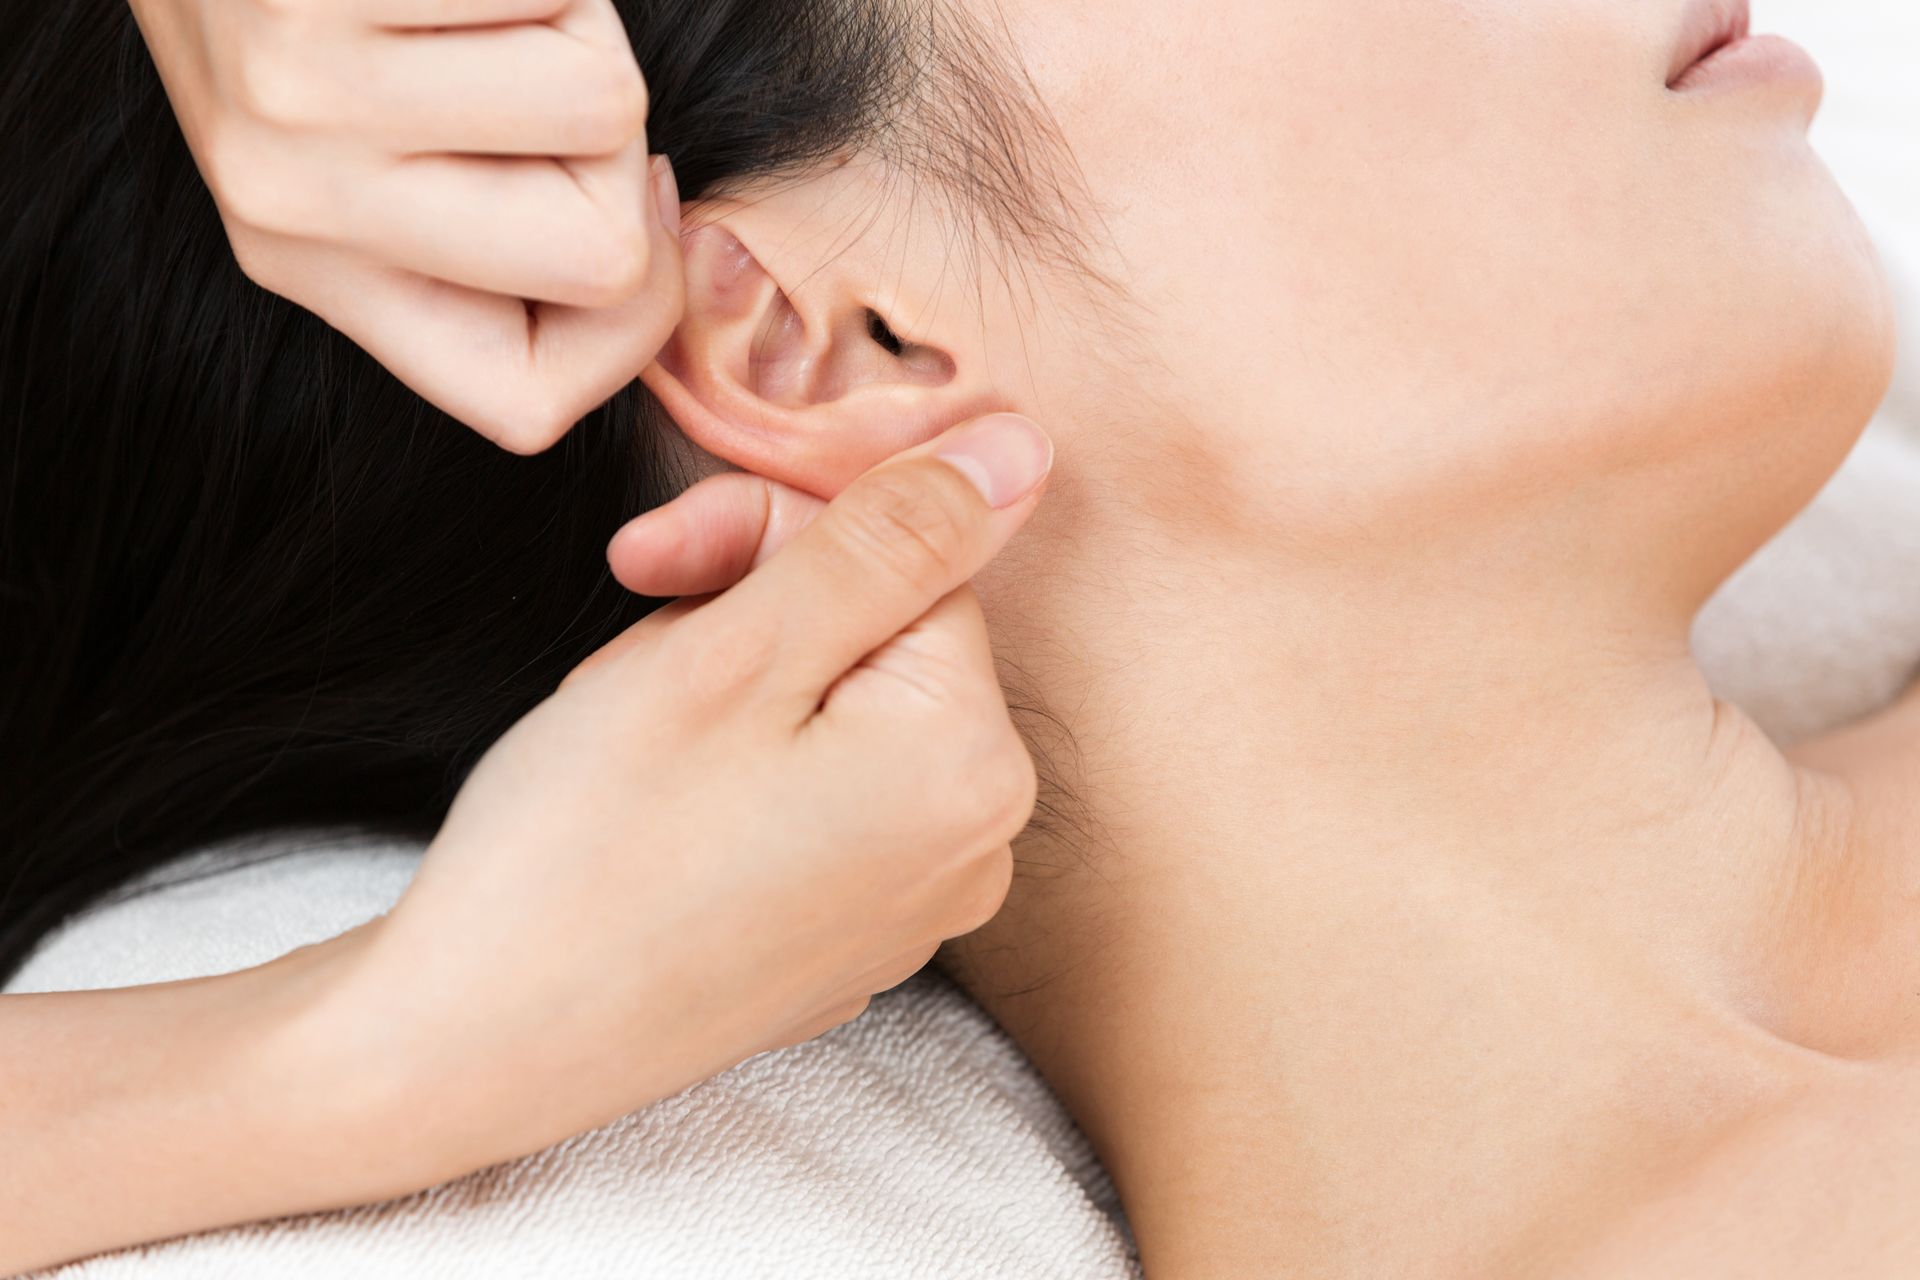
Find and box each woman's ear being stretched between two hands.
[641,217,996,497]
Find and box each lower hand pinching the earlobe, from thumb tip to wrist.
[328,416,1052,1174]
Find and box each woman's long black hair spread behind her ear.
[0,0,1067,977]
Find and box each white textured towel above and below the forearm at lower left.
[17,839,1135,1280]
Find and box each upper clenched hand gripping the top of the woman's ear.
[120,0,684,453]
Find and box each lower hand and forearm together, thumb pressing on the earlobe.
[0,416,1052,1274]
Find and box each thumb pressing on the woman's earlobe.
[697,415,1052,693]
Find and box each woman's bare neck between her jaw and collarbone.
[947,514,1843,1276]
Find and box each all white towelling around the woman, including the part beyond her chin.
[15,25,1920,1280]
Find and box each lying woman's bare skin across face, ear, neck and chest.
[629,0,1920,1276]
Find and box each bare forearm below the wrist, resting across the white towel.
[0,933,439,1274]
